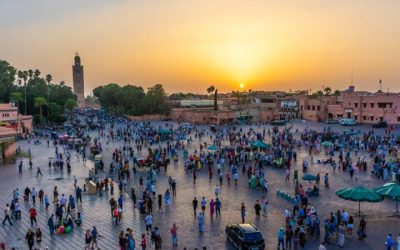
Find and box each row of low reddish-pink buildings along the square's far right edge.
[169,86,400,125]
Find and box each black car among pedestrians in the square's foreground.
[225,223,265,250]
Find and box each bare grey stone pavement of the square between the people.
[0,120,400,249]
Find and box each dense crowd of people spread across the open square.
[3,110,400,250]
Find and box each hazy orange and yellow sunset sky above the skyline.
[0,0,400,94]
